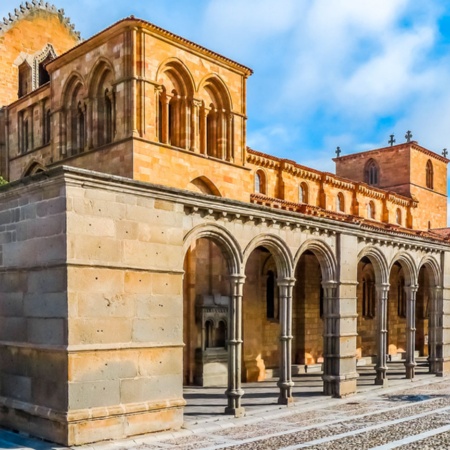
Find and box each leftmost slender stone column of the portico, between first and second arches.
[225,275,245,417]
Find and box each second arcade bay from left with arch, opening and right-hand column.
[243,235,293,404]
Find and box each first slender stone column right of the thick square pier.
[375,283,389,386]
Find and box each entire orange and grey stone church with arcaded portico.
[0,0,450,445]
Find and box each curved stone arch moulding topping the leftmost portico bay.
[183,224,243,275]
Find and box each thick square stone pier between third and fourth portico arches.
[322,281,358,397]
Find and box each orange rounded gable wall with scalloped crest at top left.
[0,7,79,107]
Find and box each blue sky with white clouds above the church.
[0,0,450,172]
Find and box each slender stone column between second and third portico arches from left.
[278,278,295,405]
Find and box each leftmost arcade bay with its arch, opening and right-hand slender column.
[183,224,244,417]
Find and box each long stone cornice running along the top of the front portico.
[0,166,450,252]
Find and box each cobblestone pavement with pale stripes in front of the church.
[0,368,450,450]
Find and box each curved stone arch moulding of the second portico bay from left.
[243,234,293,279]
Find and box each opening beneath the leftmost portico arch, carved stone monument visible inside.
[183,238,231,387]
